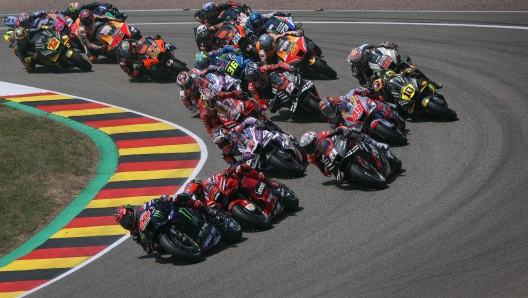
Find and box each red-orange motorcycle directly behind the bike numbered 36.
[213,22,260,61]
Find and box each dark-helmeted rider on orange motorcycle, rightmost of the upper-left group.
[116,34,161,82]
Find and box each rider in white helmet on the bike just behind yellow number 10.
[347,42,442,89]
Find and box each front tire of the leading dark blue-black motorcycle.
[160,234,204,263]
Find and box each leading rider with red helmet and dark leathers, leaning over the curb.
[115,179,223,254]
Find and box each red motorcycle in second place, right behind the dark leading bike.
[207,175,299,230]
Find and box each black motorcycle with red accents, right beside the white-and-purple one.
[321,131,402,188]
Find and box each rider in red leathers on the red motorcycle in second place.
[204,163,291,206]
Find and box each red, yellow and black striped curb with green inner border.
[0,82,207,297]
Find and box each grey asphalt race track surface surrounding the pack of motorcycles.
[0,11,528,297]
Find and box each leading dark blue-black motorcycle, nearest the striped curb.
[139,203,242,263]
